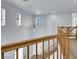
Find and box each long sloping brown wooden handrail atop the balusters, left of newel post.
[1,35,57,52]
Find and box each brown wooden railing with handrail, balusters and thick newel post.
[1,27,69,59]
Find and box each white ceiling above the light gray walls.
[3,0,77,14]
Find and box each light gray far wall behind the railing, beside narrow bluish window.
[34,13,72,37]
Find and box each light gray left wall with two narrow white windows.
[1,0,33,59]
